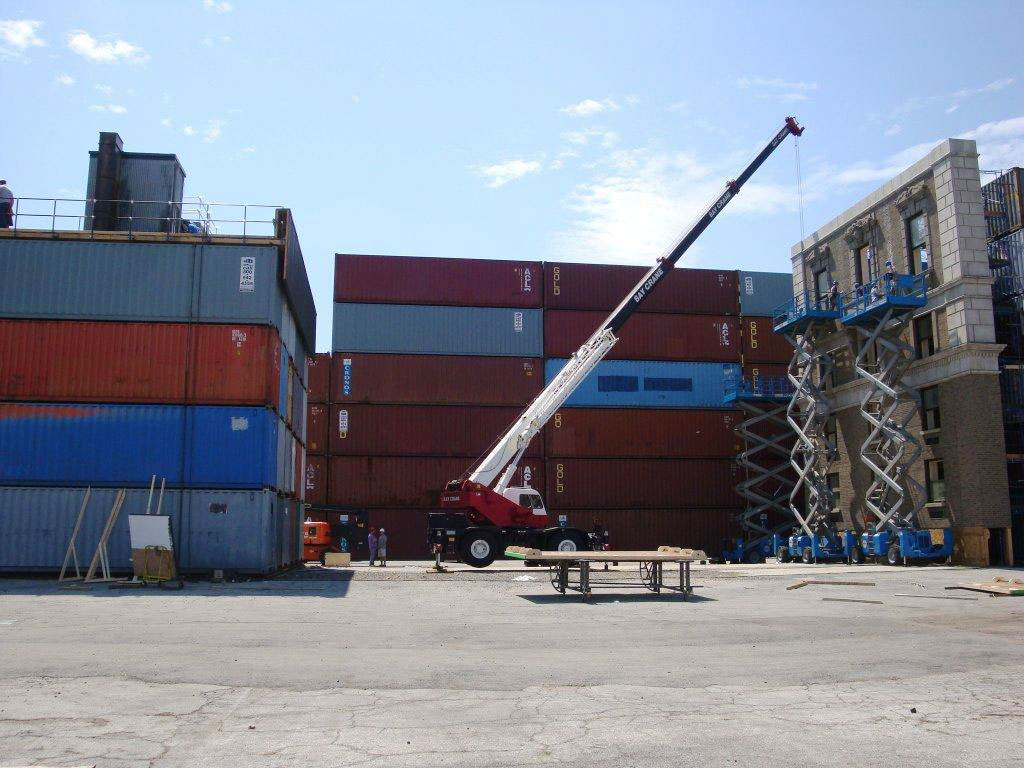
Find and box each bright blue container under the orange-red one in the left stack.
[0,403,287,488]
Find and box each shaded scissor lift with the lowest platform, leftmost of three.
[722,376,793,562]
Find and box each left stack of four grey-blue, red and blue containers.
[0,228,315,572]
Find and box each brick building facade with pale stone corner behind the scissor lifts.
[792,139,1013,564]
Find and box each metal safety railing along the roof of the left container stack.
[8,197,283,240]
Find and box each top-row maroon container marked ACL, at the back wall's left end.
[334,253,544,307]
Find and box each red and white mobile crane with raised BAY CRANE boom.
[428,117,804,568]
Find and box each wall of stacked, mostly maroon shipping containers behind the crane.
[327,255,791,557]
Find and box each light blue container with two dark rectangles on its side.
[544,359,739,409]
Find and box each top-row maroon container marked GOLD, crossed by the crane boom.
[544,263,739,314]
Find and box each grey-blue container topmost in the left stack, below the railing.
[0,239,306,362]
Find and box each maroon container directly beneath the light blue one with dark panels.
[544,408,741,459]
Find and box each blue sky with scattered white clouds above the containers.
[0,0,1024,349]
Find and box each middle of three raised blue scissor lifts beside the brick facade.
[774,291,852,563]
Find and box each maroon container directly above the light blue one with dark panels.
[544,309,740,362]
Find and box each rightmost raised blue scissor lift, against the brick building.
[841,273,952,565]
